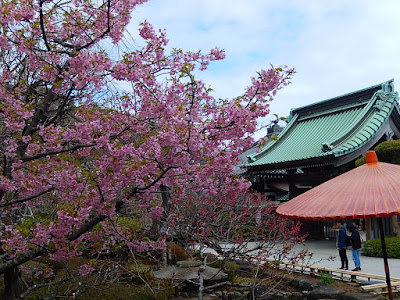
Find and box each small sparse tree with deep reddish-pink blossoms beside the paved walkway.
[168,189,309,299]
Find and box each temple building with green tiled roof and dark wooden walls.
[246,80,400,238]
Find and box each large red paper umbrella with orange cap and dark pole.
[276,151,400,299]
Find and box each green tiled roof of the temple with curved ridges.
[247,80,399,168]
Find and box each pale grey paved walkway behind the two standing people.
[295,240,400,278]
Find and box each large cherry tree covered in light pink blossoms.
[0,0,294,299]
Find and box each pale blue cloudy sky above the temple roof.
[129,0,400,138]
